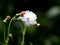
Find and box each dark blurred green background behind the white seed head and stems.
[0,0,60,45]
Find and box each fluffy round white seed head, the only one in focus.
[18,11,37,26]
